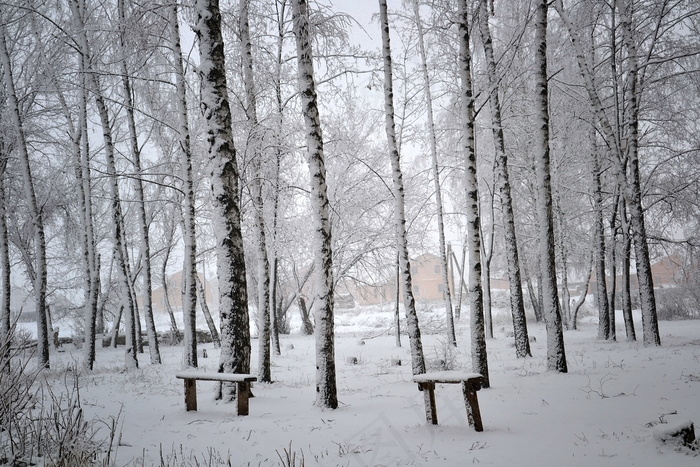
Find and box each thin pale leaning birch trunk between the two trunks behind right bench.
[413,0,457,346]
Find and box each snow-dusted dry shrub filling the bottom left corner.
[0,333,118,467]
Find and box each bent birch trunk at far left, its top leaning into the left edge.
[0,25,49,368]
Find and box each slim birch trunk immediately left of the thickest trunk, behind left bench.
[170,2,198,367]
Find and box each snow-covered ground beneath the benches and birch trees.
[28,309,700,467]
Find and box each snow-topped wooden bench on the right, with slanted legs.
[413,371,484,431]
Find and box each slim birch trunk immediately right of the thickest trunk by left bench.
[239,0,272,383]
